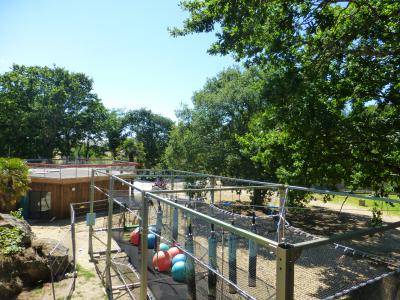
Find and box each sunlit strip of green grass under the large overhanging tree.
[310,194,400,216]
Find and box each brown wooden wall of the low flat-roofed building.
[30,177,128,219]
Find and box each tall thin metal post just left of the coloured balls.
[140,192,149,300]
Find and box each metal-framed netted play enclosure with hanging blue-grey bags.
[71,169,400,299]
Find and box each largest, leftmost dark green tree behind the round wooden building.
[0,65,106,158]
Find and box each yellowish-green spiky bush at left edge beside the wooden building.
[0,158,29,213]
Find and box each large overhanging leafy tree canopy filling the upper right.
[172,0,400,195]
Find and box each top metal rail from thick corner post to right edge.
[293,221,400,249]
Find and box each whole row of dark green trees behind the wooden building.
[0,65,173,167]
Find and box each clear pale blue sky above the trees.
[0,0,234,118]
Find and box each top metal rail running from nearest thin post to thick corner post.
[145,192,278,249]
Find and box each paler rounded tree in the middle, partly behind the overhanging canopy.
[164,68,262,178]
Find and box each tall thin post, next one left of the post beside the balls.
[106,175,114,299]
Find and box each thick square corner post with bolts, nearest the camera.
[276,244,295,300]
